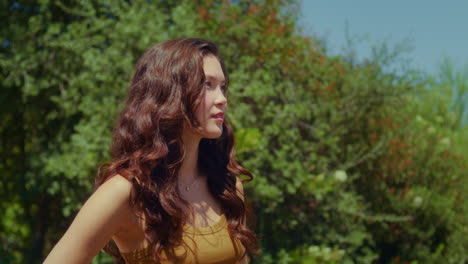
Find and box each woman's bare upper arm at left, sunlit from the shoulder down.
[44,175,132,264]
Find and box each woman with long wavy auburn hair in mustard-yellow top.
[45,38,257,264]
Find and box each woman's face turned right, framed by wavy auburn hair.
[189,55,227,138]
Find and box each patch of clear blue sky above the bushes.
[299,0,468,73]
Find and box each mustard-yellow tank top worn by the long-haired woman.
[120,214,243,264]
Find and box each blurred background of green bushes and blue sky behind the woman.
[0,0,468,264]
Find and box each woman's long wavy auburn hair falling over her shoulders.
[96,38,258,263]
